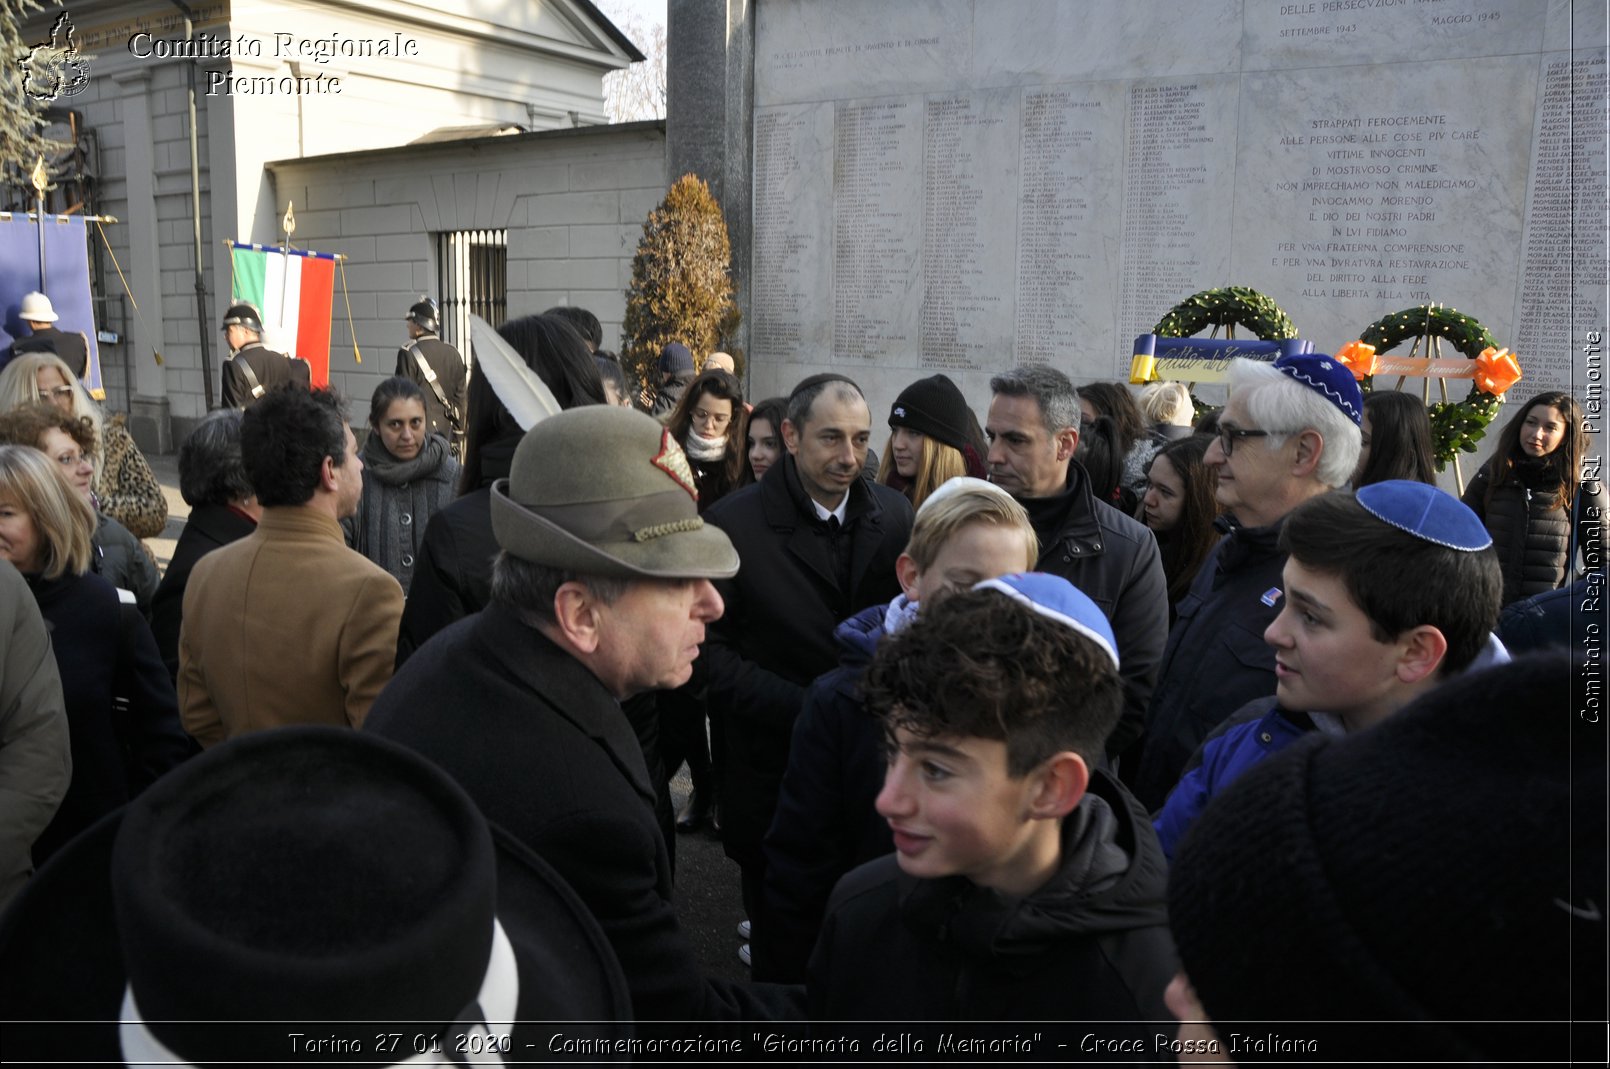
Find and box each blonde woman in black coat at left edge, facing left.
[0,446,195,865]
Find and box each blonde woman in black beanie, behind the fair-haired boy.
[877,375,987,509]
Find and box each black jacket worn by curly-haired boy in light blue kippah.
[805,771,1175,1023]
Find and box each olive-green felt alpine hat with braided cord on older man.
[493,404,737,580]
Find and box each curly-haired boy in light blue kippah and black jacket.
[807,573,1174,1030]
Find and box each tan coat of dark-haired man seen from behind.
[179,507,403,747]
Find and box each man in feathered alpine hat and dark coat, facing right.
[364,406,802,1027]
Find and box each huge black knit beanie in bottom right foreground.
[1169,654,1610,1061]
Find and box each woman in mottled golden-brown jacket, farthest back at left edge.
[0,353,167,538]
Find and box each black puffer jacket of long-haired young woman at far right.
[1462,459,1605,605]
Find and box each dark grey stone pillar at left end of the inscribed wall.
[665,0,755,363]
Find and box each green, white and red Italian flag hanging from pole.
[230,241,335,386]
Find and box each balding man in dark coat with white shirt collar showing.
[705,375,913,965]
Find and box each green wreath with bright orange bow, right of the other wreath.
[1359,304,1520,470]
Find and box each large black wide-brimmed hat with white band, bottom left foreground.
[0,728,631,1064]
